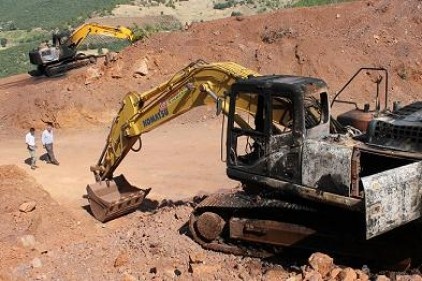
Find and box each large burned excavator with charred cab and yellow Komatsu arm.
[87,61,422,264]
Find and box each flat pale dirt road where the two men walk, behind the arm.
[0,115,237,217]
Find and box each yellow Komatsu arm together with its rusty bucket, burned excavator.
[87,60,258,221]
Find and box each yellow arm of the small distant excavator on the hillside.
[65,23,133,49]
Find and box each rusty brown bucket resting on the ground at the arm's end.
[86,175,151,222]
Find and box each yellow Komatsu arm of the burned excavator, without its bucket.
[91,60,258,181]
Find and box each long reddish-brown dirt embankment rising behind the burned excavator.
[0,0,422,132]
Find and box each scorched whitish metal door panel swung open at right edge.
[362,162,422,239]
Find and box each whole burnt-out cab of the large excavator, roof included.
[227,76,330,183]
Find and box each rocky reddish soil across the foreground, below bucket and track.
[0,165,422,281]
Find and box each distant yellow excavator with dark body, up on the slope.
[29,23,134,77]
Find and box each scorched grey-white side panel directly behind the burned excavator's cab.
[302,138,353,196]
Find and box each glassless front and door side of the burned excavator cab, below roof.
[227,89,301,182]
